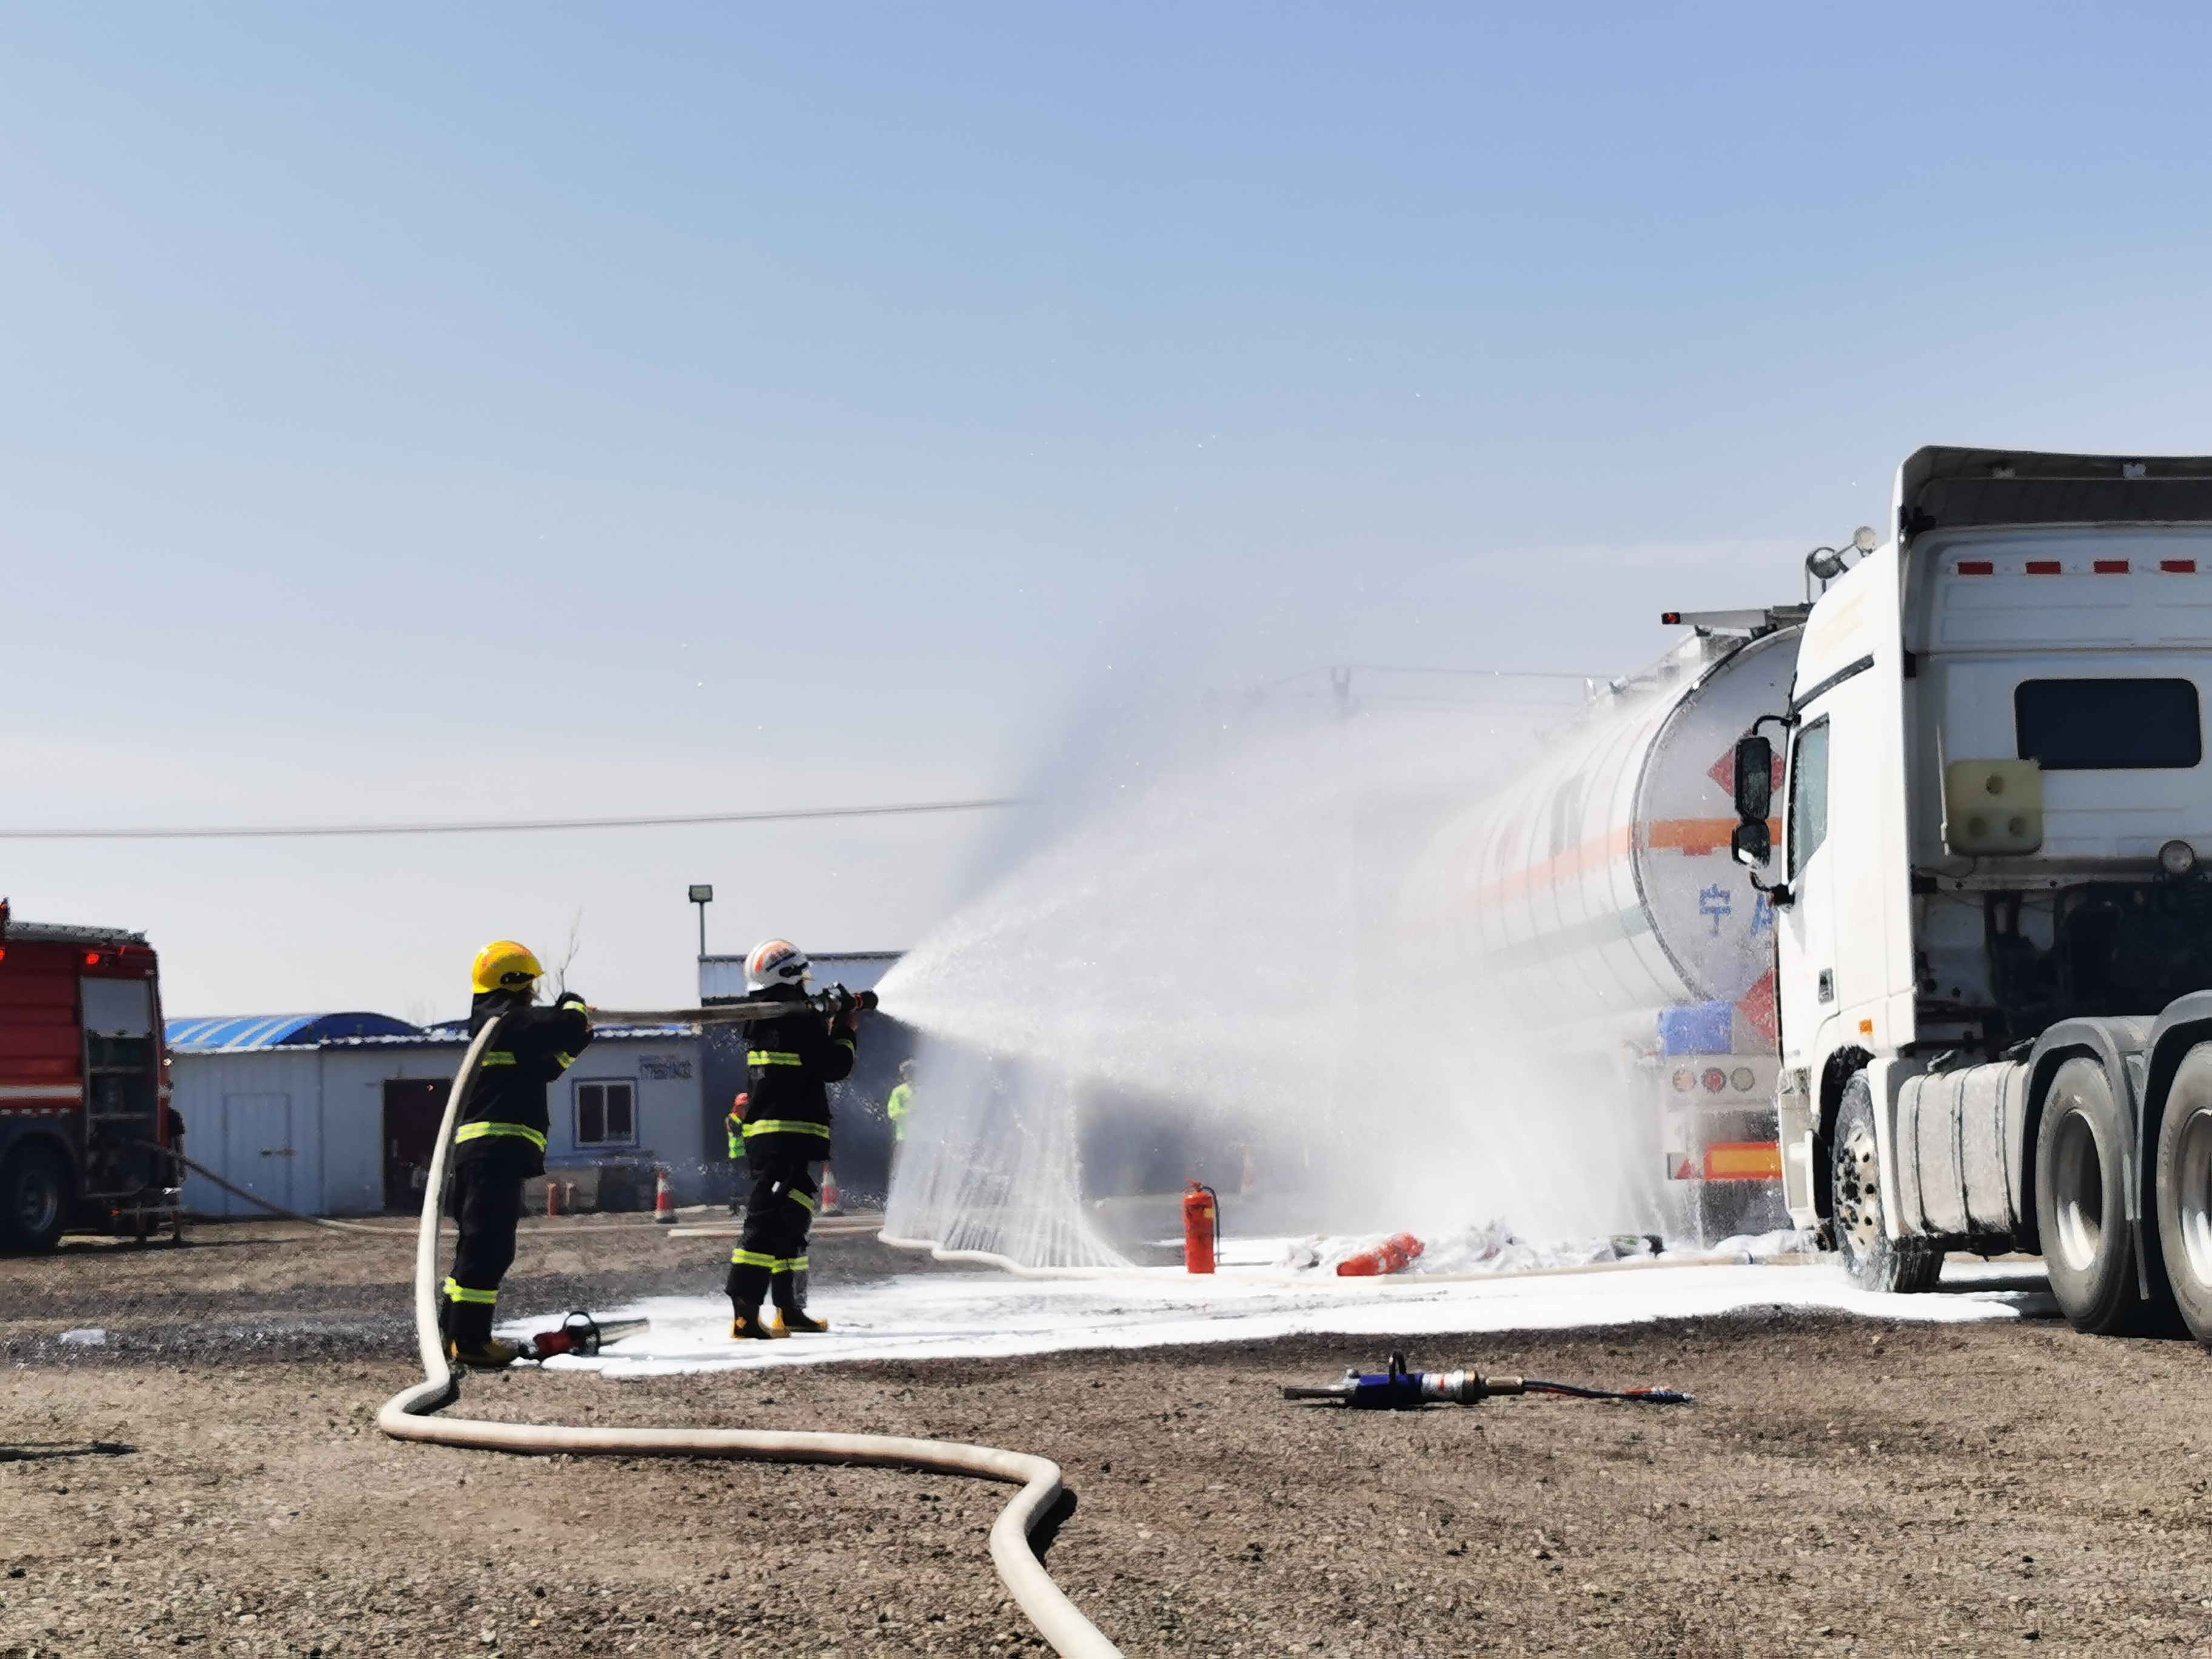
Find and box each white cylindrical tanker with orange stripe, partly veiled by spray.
[1411,608,1803,1241]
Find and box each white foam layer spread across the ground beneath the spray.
[506,1250,2057,1378]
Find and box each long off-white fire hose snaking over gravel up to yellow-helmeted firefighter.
[376,1020,1122,1659]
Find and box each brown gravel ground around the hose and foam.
[0,1221,2212,1659]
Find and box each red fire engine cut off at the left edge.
[0,900,181,1250]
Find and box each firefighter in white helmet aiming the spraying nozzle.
[728,938,858,1341]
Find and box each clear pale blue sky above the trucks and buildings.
[0,4,2212,1013]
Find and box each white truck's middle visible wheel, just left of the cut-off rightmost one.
[2035,1055,2157,1336]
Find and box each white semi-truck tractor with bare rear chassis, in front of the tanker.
[1732,449,2212,1342]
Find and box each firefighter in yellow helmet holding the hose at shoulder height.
[440,940,591,1369]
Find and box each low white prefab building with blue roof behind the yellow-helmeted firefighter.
[166,1013,703,1215]
